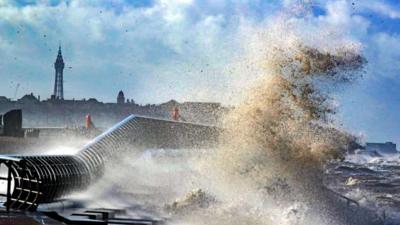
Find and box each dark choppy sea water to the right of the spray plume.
[325,151,400,224]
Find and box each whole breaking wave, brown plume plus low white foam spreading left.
[79,11,380,225]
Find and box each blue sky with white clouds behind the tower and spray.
[0,0,400,144]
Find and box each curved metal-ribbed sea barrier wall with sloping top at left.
[0,115,220,210]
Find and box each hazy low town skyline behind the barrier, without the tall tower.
[0,91,225,128]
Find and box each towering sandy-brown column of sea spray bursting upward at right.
[176,19,382,224]
